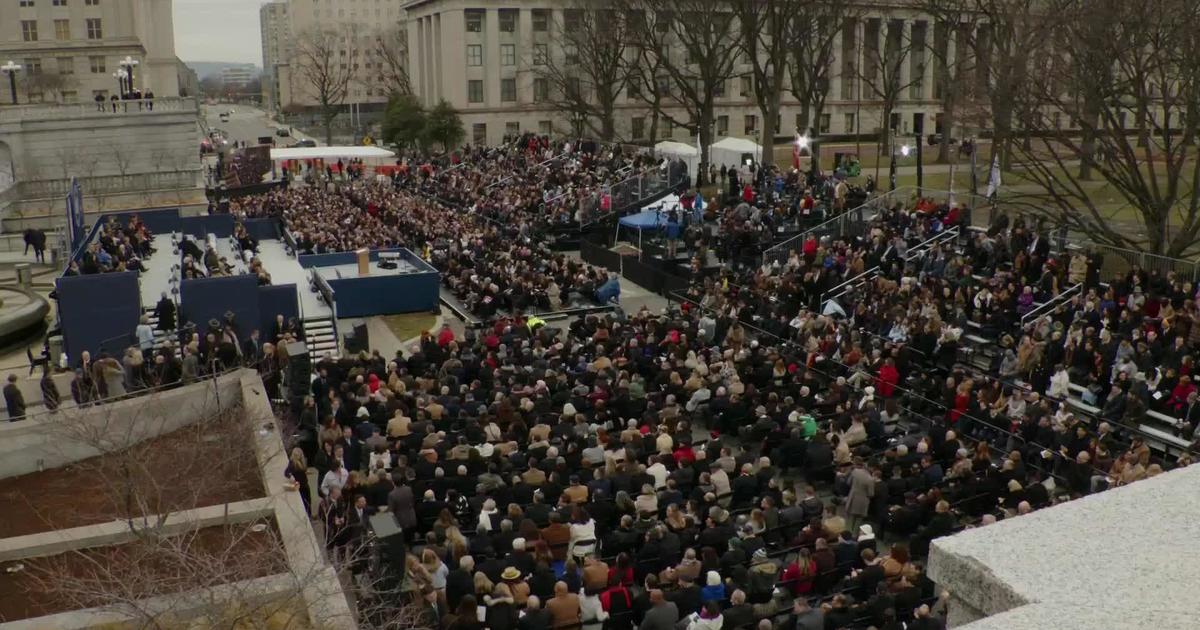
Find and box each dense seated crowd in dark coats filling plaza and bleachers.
[35,129,1200,630]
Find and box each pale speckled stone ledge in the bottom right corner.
[929,466,1200,630]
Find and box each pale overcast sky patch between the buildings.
[174,0,263,64]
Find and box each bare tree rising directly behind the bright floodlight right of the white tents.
[785,0,862,166]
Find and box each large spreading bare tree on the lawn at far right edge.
[1013,0,1200,257]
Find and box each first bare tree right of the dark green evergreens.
[532,5,631,142]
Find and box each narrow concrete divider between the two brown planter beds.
[0,498,275,563]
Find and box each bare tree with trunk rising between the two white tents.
[623,0,742,182]
